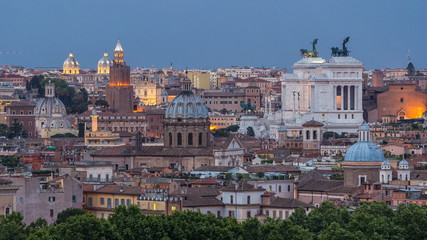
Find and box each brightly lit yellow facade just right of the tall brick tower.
[133,81,162,106]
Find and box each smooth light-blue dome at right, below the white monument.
[344,141,385,162]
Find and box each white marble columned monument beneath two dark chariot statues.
[276,57,363,132]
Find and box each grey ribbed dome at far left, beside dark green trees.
[35,97,67,117]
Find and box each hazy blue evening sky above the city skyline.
[0,0,427,69]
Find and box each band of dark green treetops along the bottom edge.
[0,203,427,240]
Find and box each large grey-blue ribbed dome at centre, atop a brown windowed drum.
[165,91,209,118]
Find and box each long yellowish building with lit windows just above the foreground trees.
[83,185,181,218]
